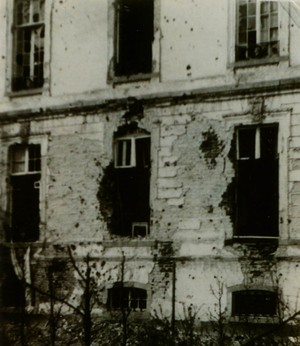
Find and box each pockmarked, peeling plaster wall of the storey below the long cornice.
[1,87,300,316]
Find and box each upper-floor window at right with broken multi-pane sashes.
[236,0,279,61]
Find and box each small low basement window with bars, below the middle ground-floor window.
[107,283,147,311]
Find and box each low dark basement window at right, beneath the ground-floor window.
[232,290,277,316]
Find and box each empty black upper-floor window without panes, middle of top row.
[115,0,154,76]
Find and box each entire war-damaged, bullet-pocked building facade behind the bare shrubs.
[0,0,300,344]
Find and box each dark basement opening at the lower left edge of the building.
[0,247,25,307]
